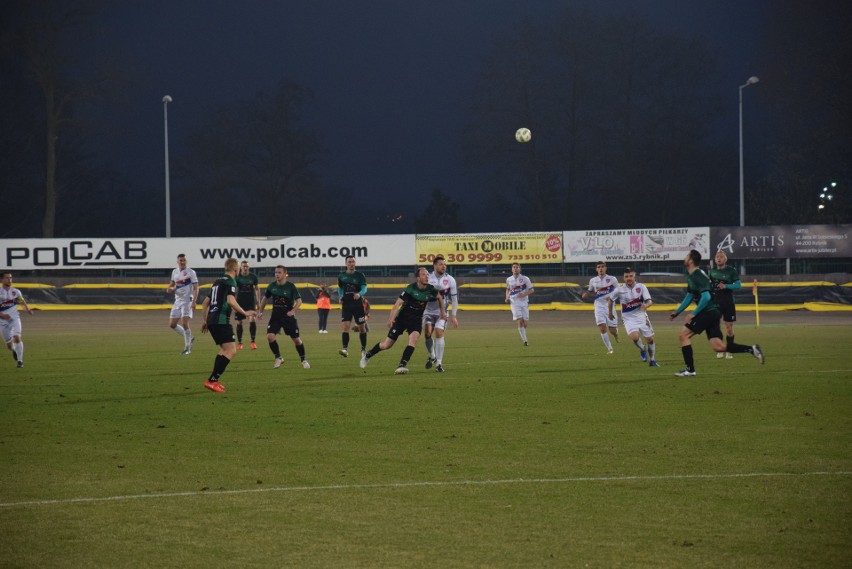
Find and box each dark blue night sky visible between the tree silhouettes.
[4,0,852,235]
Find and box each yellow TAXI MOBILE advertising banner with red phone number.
[415,231,562,265]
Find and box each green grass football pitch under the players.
[0,312,852,568]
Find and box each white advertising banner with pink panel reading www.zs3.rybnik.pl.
[564,227,710,263]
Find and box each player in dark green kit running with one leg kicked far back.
[669,249,765,377]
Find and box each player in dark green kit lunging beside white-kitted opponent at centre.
[361,268,447,374]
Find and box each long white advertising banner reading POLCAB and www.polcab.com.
[0,234,414,271]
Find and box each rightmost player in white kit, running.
[606,267,660,367]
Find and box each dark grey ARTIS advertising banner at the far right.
[710,225,852,259]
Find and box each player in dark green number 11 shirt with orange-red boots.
[201,259,255,393]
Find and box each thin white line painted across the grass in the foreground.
[0,471,852,508]
